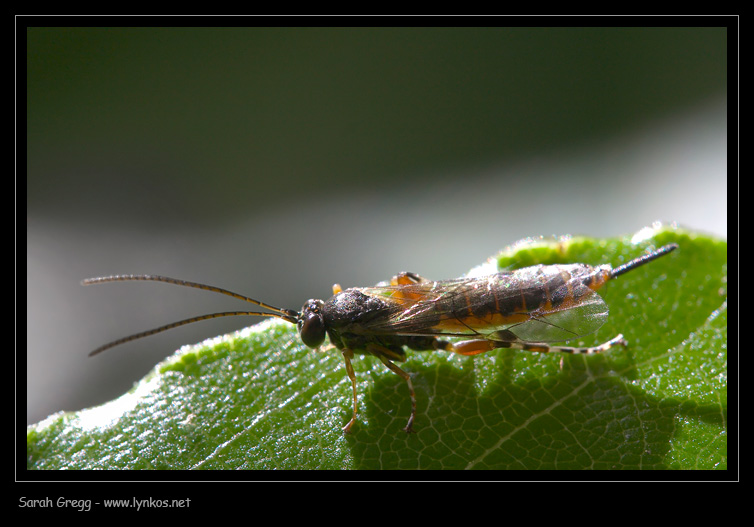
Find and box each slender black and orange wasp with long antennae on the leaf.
[81,244,678,433]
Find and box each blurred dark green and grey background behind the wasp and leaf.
[26,27,727,423]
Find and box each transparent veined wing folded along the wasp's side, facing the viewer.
[360,272,608,342]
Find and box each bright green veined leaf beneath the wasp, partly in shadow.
[27,227,728,469]
